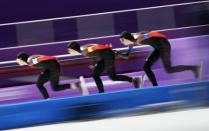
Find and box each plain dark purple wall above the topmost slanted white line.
[0,0,201,23]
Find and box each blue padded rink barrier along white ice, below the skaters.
[0,81,209,130]
